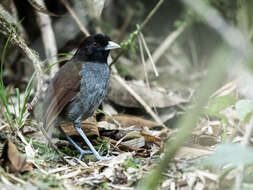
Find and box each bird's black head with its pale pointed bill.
[74,34,120,63]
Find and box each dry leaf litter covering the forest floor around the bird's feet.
[0,78,252,189]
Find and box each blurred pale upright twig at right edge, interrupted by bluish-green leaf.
[235,116,253,190]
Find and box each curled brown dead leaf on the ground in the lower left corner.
[1,140,32,173]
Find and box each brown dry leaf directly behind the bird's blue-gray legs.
[61,117,99,136]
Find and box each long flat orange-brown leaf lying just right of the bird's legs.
[102,114,160,128]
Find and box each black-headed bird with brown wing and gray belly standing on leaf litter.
[43,34,120,160]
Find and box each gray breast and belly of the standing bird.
[57,63,110,123]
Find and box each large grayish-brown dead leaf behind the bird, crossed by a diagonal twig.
[108,78,187,108]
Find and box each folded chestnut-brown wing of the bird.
[43,60,82,131]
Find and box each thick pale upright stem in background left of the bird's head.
[36,0,59,77]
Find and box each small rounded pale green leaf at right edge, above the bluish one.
[235,100,253,121]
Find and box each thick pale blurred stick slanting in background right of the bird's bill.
[144,23,188,68]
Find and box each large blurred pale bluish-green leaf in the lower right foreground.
[208,143,253,167]
